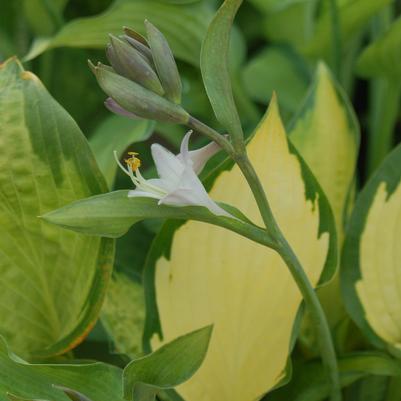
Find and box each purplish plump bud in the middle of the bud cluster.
[106,35,164,96]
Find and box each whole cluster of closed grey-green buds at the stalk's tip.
[89,21,189,124]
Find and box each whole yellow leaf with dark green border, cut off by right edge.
[341,145,401,355]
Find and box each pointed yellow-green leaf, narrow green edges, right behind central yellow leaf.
[289,63,359,238]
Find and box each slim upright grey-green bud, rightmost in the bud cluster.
[145,20,182,104]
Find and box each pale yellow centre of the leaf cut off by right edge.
[356,183,401,349]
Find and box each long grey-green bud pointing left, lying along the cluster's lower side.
[89,61,189,124]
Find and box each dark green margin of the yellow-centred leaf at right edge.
[340,144,401,357]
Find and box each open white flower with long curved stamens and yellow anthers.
[114,131,233,217]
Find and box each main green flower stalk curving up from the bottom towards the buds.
[190,117,342,401]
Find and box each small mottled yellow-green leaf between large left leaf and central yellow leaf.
[101,273,145,358]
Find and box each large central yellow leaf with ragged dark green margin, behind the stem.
[145,97,336,401]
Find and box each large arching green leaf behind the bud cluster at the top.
[26,0,211,65]
